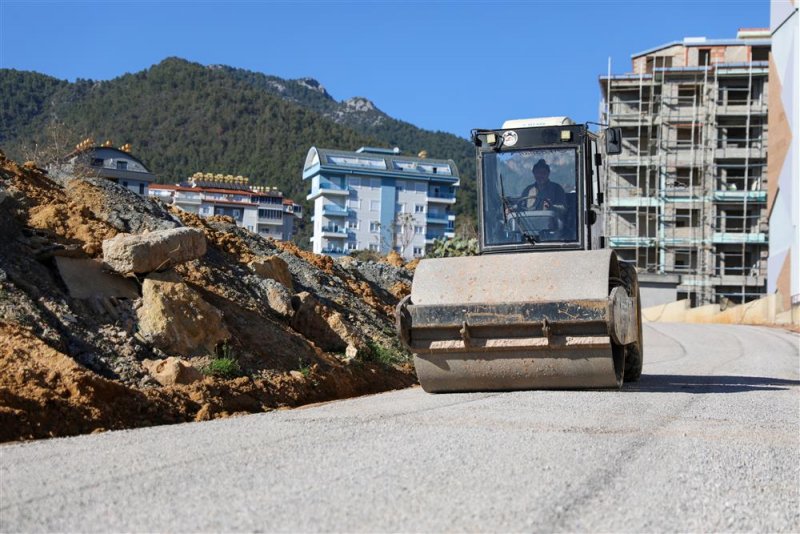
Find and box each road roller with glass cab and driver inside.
[396,117,643,393]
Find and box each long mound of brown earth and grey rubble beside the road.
[0,152,415,441]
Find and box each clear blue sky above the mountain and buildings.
[0,0,769,137]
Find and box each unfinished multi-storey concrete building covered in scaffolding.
[600,29,770,305]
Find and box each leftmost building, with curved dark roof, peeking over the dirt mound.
[59,138,156,197]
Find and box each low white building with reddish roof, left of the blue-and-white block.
[150,172,303,241]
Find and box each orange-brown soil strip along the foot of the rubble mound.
[0,322,415,442]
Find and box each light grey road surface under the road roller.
[0,324,800,532]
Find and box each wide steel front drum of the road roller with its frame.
[397,250,639,392]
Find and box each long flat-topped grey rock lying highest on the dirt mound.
[103,228,206,273]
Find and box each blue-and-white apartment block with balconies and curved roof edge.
[303,147,459,259]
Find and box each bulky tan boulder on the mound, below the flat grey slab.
[136,271,230,356]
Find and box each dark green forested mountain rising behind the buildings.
[0,58,476,243]
